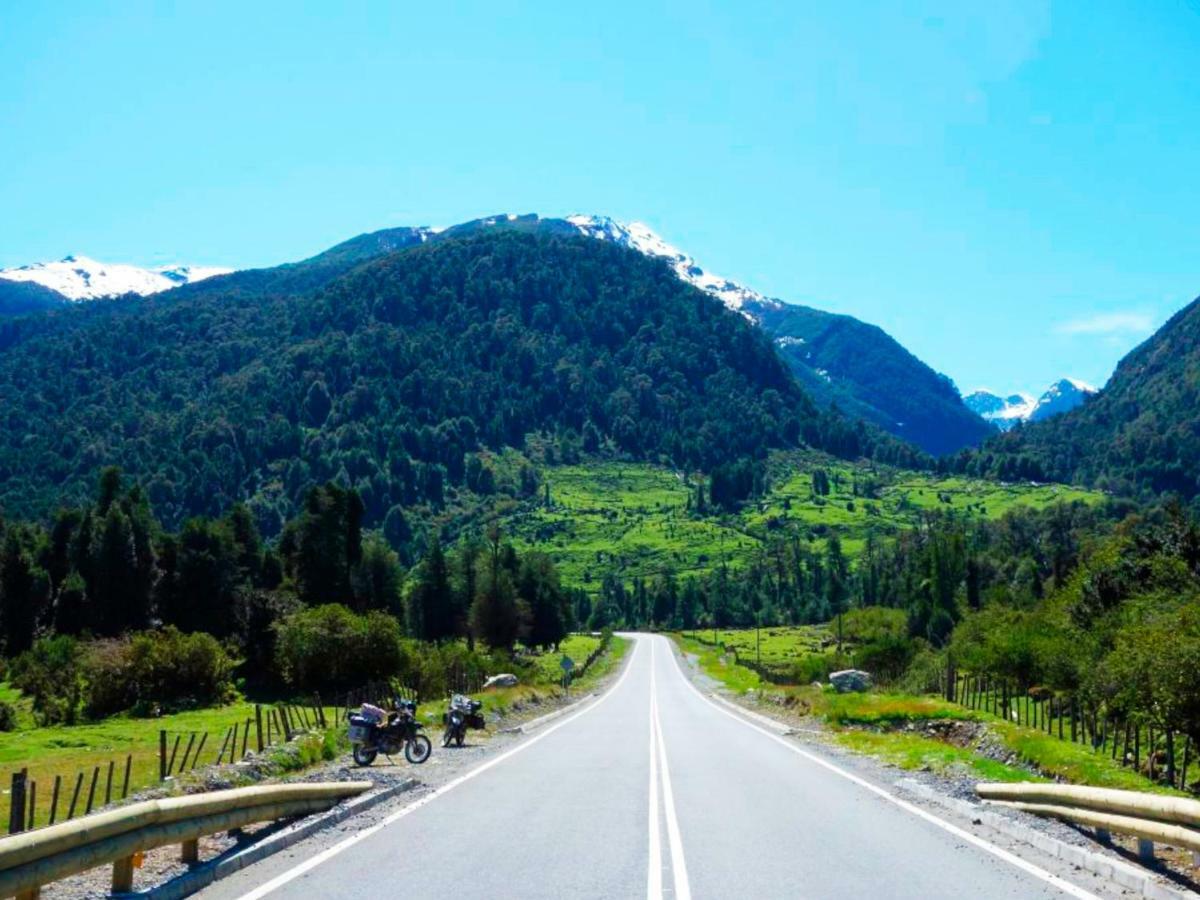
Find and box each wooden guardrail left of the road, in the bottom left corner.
[0,781,372,900]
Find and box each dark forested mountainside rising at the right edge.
[959,300,1200,499]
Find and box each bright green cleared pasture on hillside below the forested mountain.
[500,451,1103,590]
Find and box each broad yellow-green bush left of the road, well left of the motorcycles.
[83,626,234,718]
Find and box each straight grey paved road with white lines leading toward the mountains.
[229,636,1091,900]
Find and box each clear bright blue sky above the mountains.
[0,0,1200,390]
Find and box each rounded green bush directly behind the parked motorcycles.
[275,604,413,691]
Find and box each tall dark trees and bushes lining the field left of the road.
[0,468,580,724]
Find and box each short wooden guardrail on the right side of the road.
[976,782,1200,858]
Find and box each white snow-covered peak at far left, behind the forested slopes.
[0,256,232,300]
